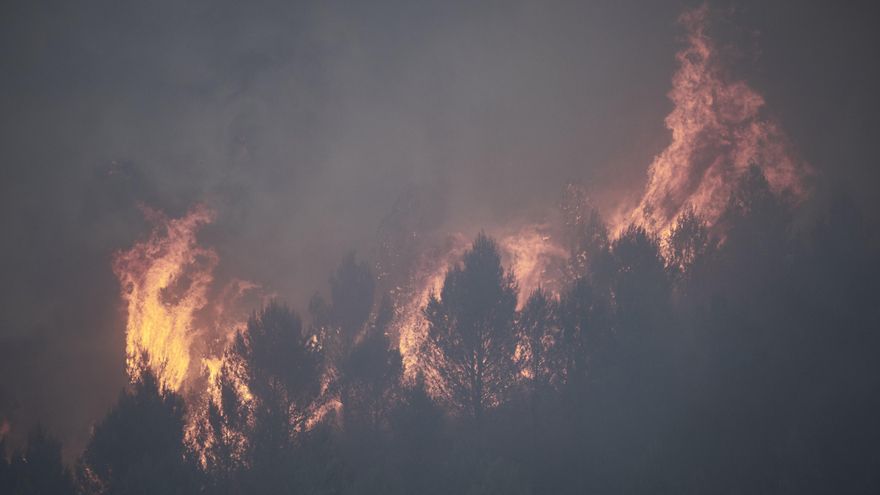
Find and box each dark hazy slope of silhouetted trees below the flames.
[0,168,880,494]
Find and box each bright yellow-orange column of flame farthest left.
[113,206,218,391]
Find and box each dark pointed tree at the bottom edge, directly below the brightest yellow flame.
[82,368,199,494]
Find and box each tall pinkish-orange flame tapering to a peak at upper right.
[614,4,809,236]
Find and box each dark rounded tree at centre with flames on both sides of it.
[424,233,517,422]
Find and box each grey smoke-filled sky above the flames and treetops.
[0,1,880,460]
